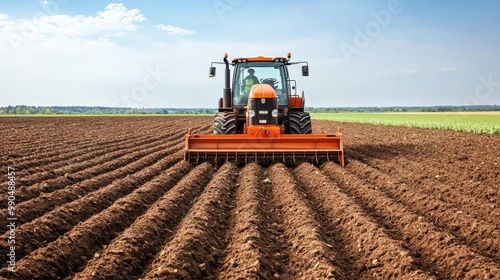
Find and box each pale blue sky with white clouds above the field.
[0,0,500,108]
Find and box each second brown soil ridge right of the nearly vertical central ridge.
[295,163,432,279]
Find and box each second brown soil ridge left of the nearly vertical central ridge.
[73,163,214,279]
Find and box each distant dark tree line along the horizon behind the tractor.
[0,105,500,115]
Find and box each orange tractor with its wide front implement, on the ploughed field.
[184,54,344,166]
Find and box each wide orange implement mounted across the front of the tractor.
[184,131,344,166]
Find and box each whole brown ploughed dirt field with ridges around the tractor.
[0,117,500,279]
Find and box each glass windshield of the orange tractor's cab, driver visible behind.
[233,62,288,106]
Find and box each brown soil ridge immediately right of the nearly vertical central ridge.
[266,164,347,279]
